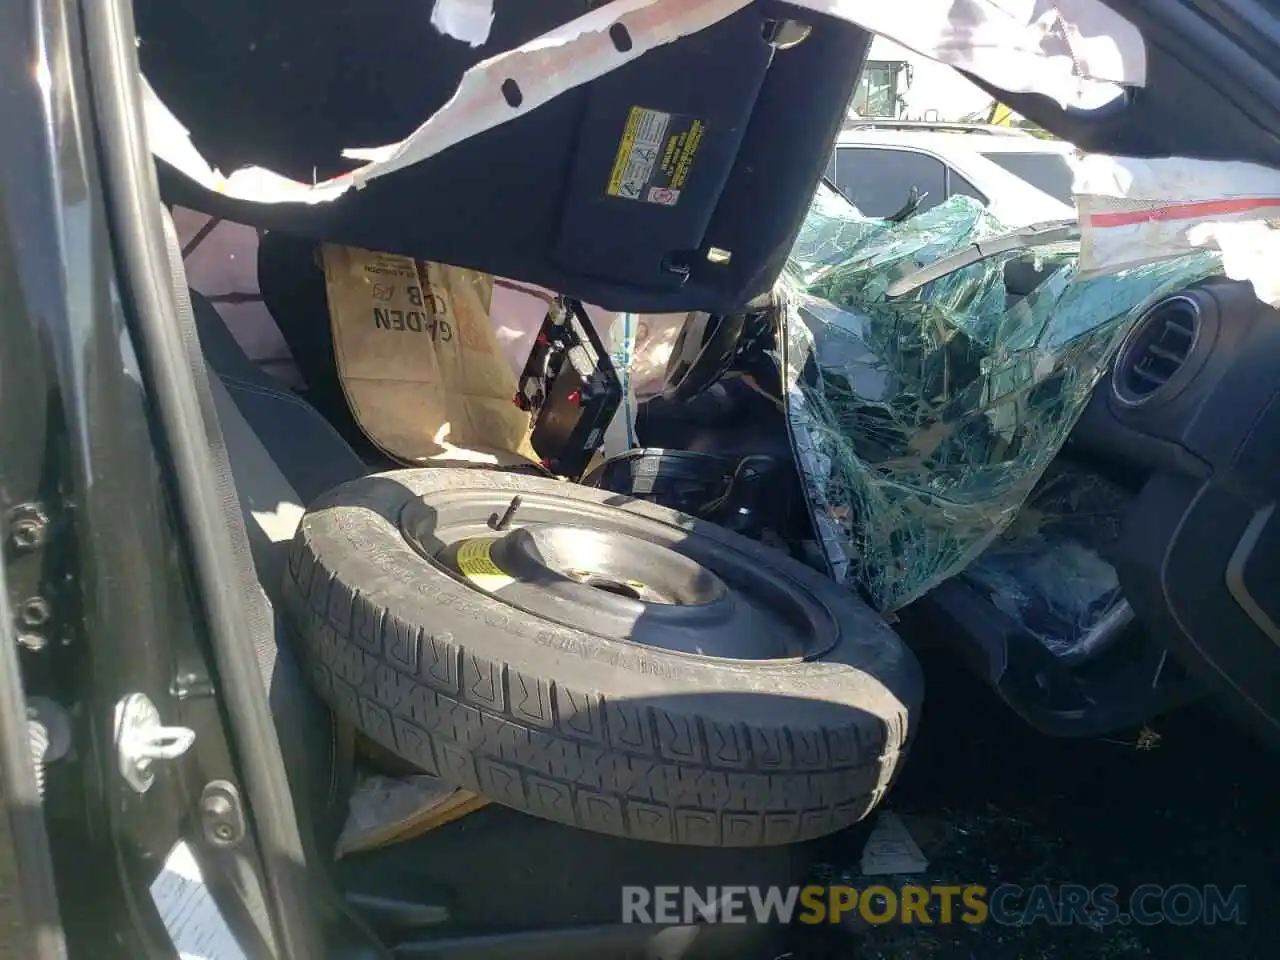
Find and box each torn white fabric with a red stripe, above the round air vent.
[1073,155,1280,306]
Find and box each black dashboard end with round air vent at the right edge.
[1064,279,1280,736]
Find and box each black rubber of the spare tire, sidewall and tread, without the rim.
[285,468,922,845]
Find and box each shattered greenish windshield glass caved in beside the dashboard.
[782,184,1220,611]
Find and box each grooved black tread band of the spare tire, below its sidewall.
[285,542,908,846]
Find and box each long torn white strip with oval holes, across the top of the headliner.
[145,0,1146,204]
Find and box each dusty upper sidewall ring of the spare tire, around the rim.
[294,468,920,717]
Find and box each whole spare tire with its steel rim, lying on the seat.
[285,468,922,846]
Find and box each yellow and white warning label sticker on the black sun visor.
[608,106,707,206]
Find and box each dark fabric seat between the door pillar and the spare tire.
[191,292,367,861]
